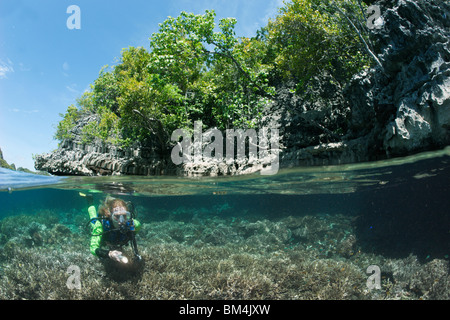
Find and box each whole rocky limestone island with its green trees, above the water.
[35,0,450,176]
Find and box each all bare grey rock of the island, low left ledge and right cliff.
[35,0,450,176]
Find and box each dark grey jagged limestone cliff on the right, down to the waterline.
[260,0,450,167]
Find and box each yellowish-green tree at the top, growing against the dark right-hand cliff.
[268,0,370,91]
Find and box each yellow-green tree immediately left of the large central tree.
[114,47,186,149]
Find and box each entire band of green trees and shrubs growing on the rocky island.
[55,0,376,148]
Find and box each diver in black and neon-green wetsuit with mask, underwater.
[80,193,142,263]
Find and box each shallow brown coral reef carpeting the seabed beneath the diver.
[0,210,450,300]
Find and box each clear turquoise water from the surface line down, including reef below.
[0,148,450,299]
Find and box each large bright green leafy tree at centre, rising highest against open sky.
[150,10,272,129]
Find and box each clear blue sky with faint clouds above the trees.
[0,0,283,170]
